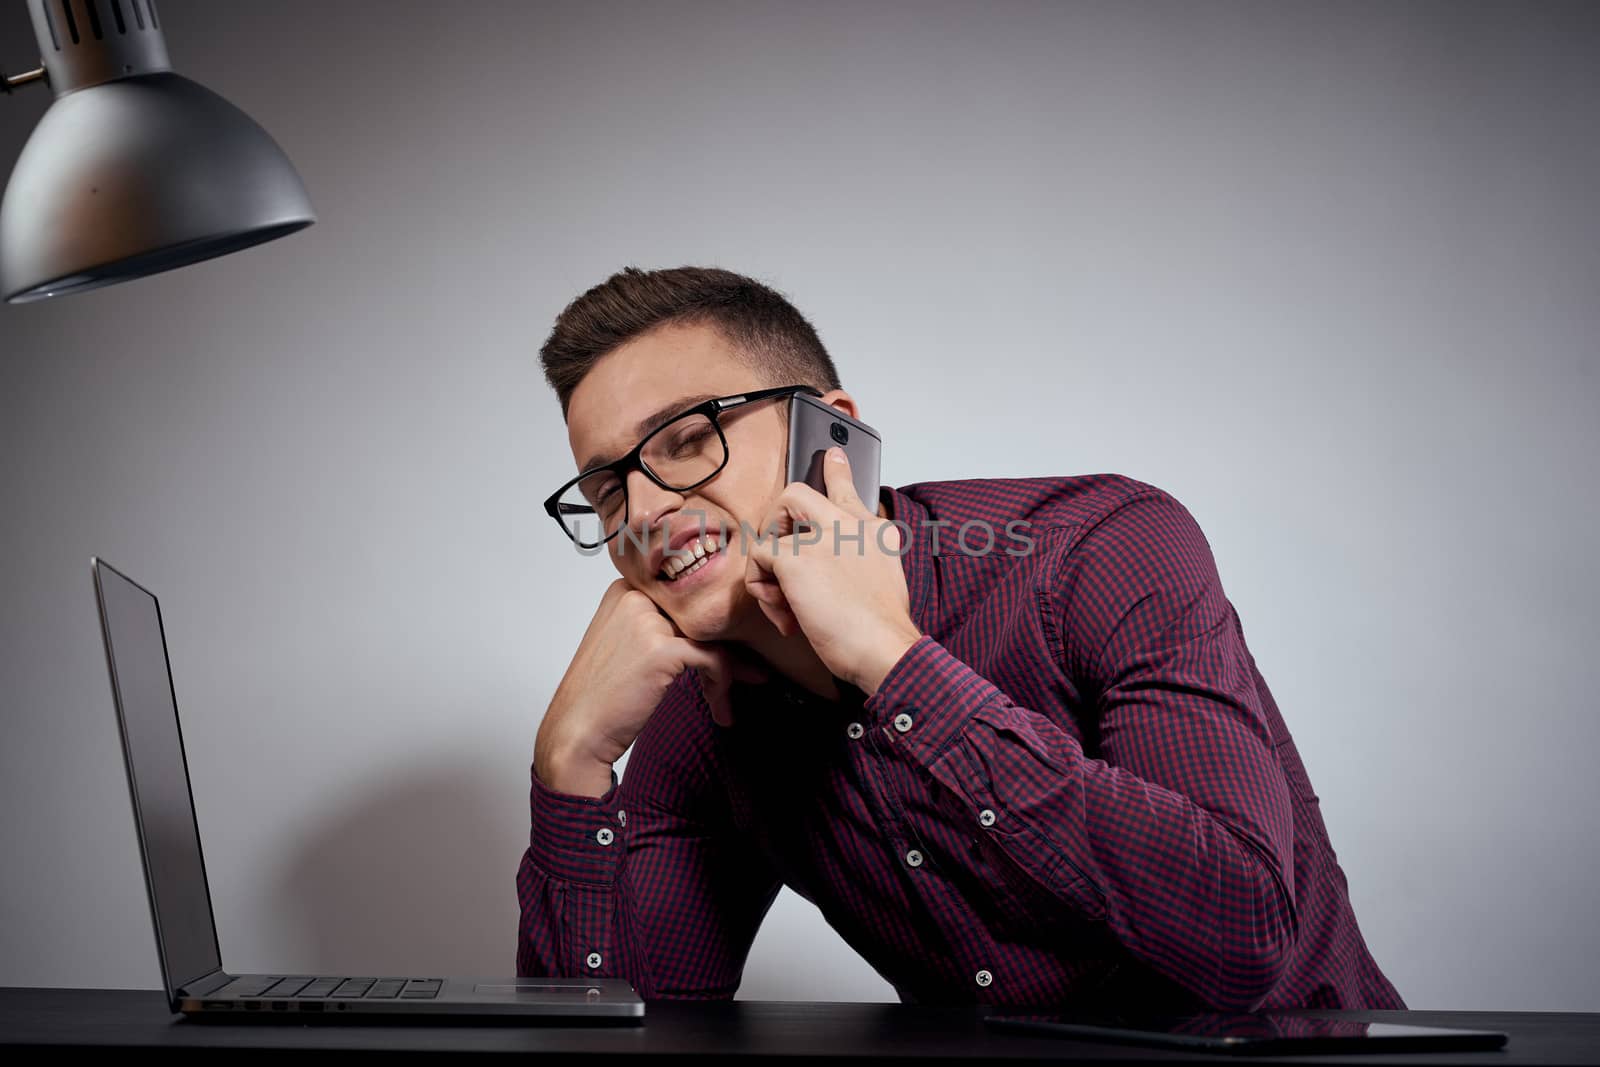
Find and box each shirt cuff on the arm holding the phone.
[861,633,1005,765]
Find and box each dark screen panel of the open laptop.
[94,560,222,997]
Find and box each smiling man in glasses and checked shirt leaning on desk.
[517,267,1405,1011]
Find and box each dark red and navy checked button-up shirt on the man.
[517,475,1405,1011]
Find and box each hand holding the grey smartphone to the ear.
[744,446,922,696]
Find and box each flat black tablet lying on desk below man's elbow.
[984,1009,1507,1056]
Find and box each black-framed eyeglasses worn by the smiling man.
[544,386,822,549]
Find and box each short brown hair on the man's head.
[539,267,840,421]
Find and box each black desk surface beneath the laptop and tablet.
[0,989,1600,1067]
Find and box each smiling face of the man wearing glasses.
[566,325,875,641]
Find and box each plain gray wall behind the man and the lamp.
[0,0,1600,1009]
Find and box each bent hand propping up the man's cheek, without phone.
[533,577,766,797]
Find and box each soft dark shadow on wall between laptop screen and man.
[277,761,518,976]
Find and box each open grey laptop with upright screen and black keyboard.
[90,557,645,1022]
